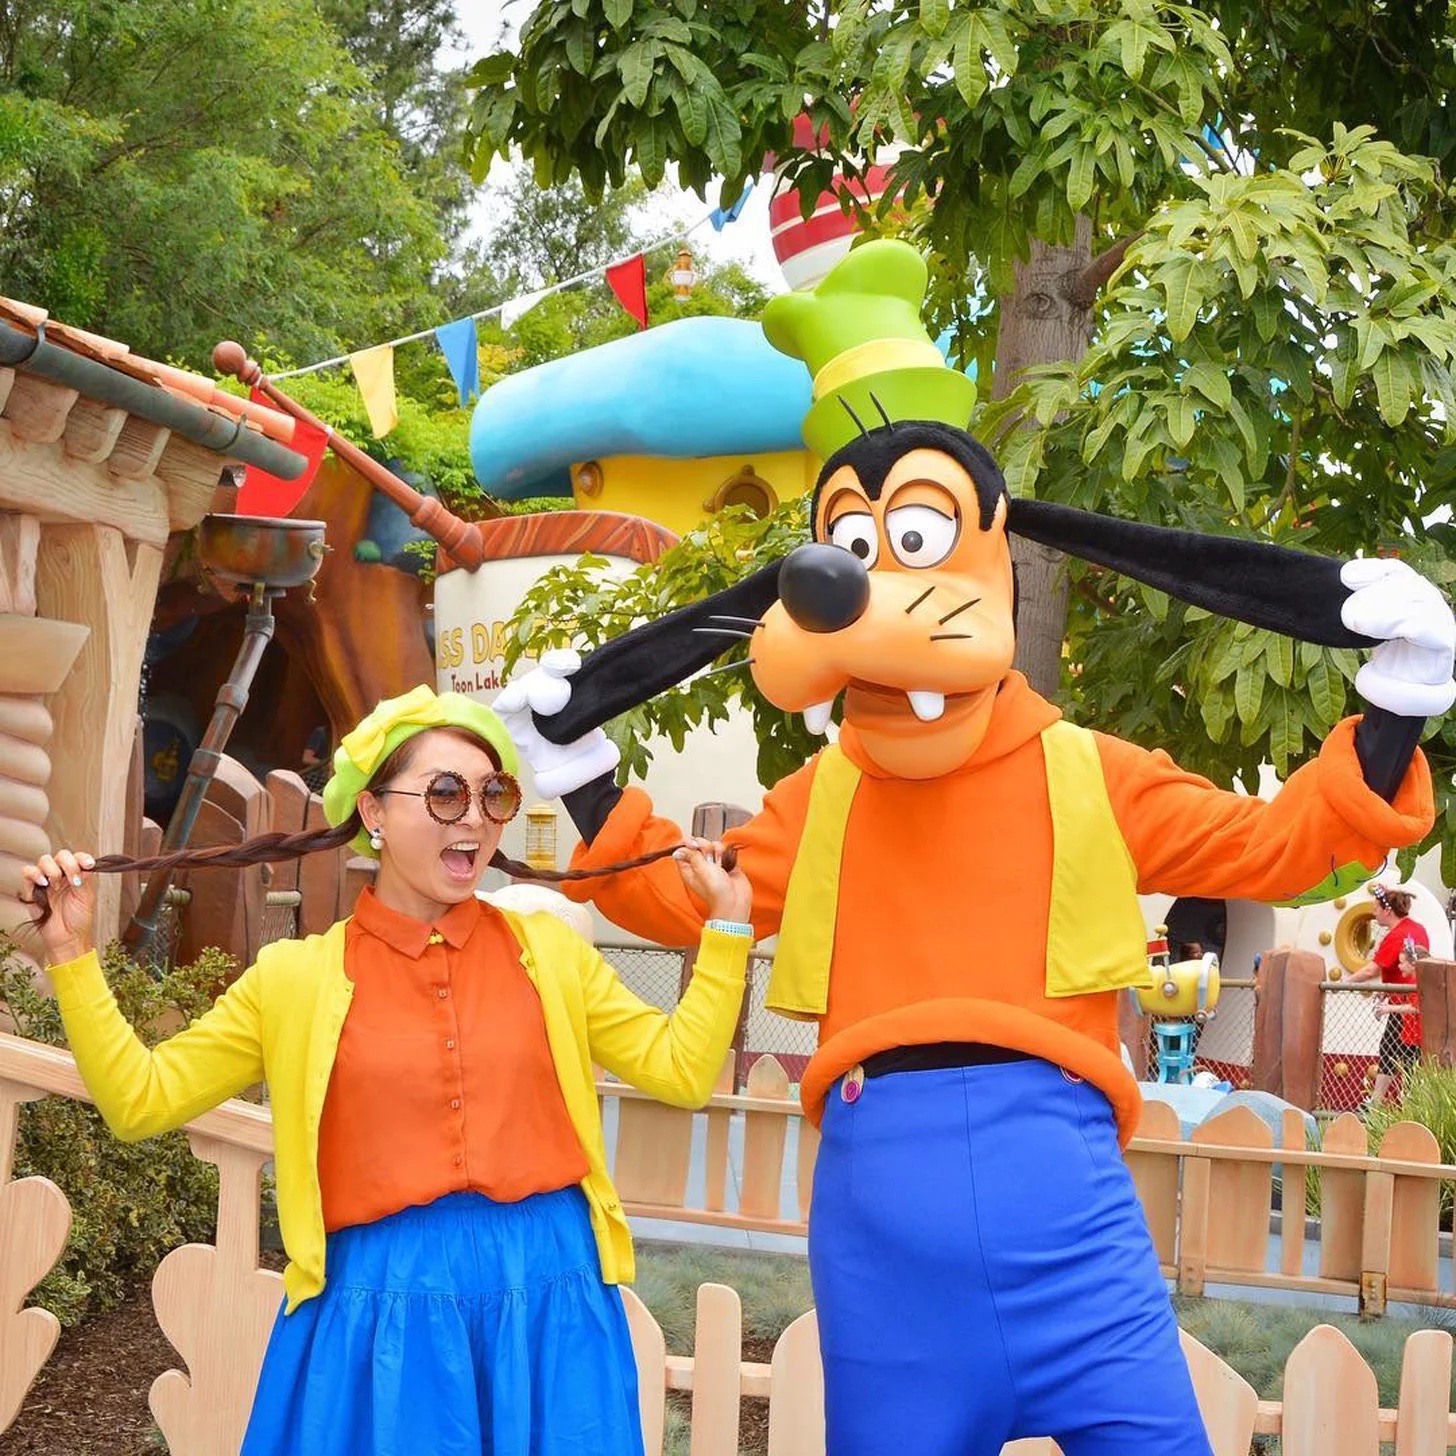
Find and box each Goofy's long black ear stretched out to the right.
[1006,499,1376,646]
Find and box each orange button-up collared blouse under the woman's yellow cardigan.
[319,888,587,1230]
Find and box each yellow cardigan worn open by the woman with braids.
[51,910,750,1313]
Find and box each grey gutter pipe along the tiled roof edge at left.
[0,320,309,480]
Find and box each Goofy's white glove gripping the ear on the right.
[1340,556,1456,718]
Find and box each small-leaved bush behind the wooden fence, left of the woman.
[0,939,236,1325]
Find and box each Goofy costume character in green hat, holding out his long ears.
[496,242,1456,1456]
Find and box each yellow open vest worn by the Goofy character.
[766,719,1147,1021]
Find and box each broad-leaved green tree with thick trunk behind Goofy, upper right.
[470,0,1456,882]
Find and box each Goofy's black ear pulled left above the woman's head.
[534,561,782,743]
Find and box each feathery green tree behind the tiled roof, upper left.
[0,0,448,367]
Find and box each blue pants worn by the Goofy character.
[810,1061,1211,1456]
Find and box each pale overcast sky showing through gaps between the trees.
[445,0,786,293]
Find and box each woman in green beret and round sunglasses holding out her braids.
[25,687,751,1456]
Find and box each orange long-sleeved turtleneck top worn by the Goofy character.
[563,673,1434,1139]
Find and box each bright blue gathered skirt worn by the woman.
[242,1188,642,1456]
